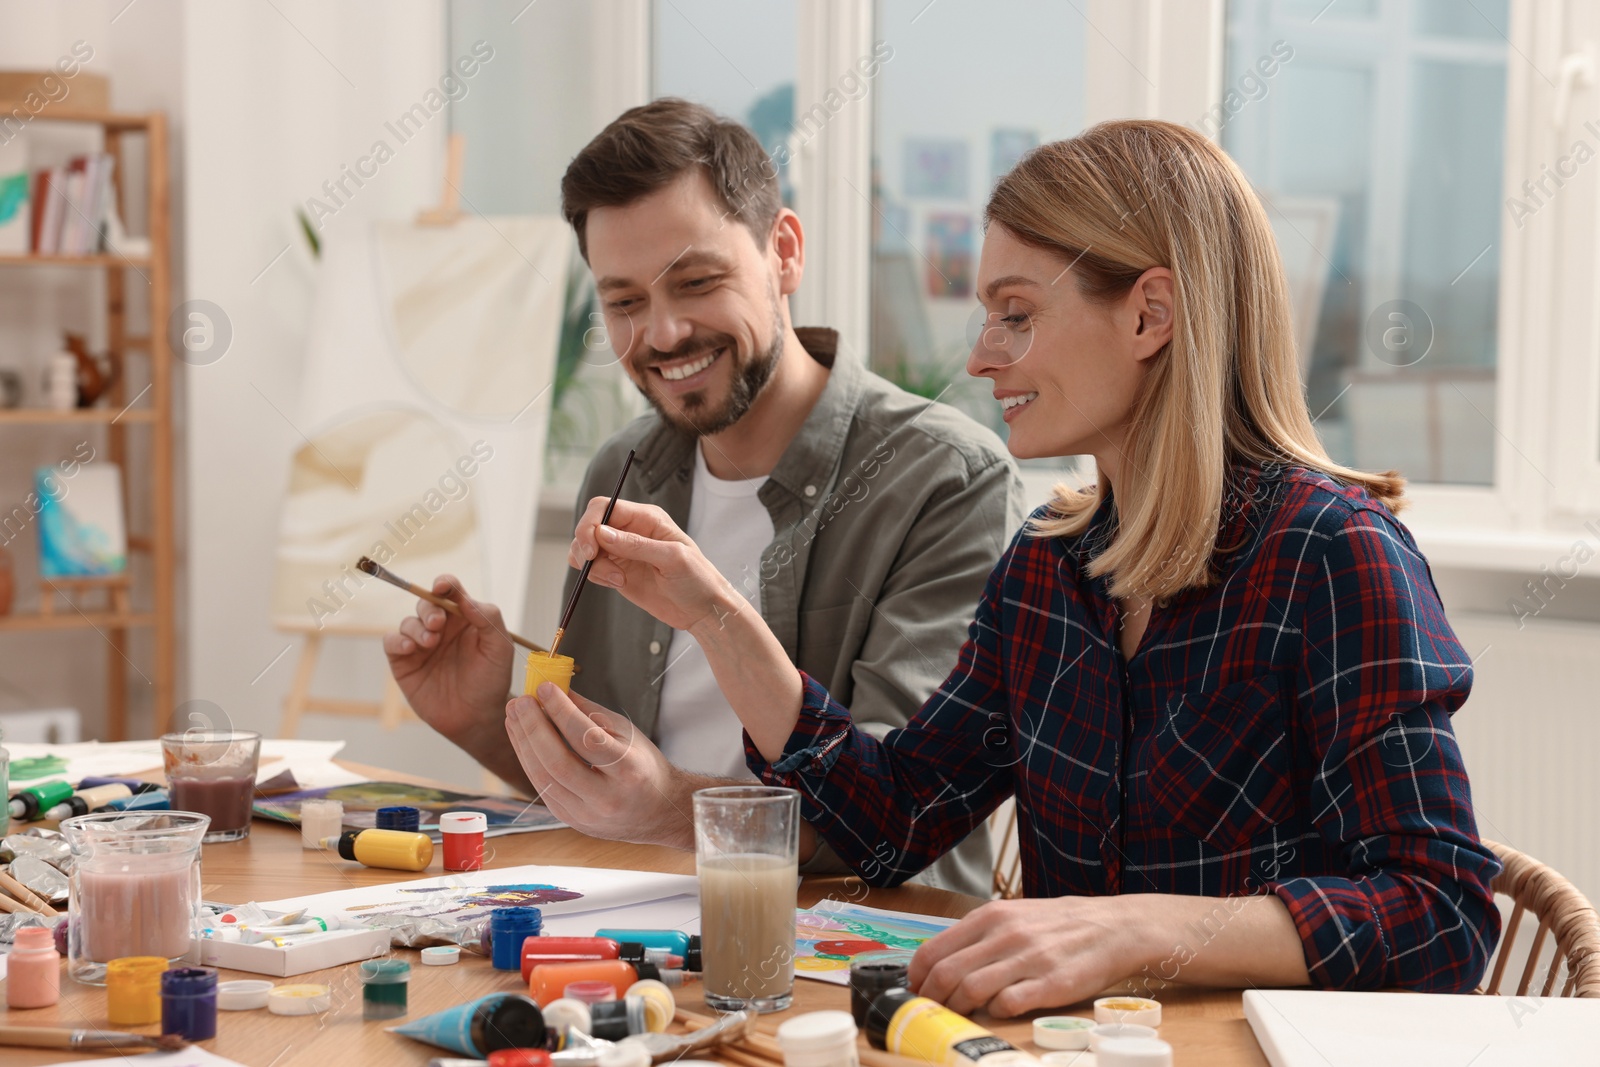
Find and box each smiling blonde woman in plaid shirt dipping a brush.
[507,122,1499,1016]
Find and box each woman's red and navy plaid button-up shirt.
[746,466,1499,992]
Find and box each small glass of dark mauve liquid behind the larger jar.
[162,729,261,845]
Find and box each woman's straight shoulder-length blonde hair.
[984,120,1405,598]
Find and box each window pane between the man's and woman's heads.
[869,0,1090,469]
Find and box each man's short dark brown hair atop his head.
[562,96,784,262]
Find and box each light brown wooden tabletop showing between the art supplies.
[0,765,1267,1067]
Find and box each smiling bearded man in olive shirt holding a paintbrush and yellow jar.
[384,99,1022,896]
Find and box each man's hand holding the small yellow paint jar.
[506,681,697,848]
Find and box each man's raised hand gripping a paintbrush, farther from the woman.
[384,574,514,758]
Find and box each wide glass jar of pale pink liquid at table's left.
[61,811,211,985]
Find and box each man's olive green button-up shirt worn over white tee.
[562,328,1024,897]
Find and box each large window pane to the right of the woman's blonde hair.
[1206,0,1509,485]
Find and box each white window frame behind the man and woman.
[614,0,1600,571]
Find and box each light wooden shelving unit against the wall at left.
[0,102,178,741]
